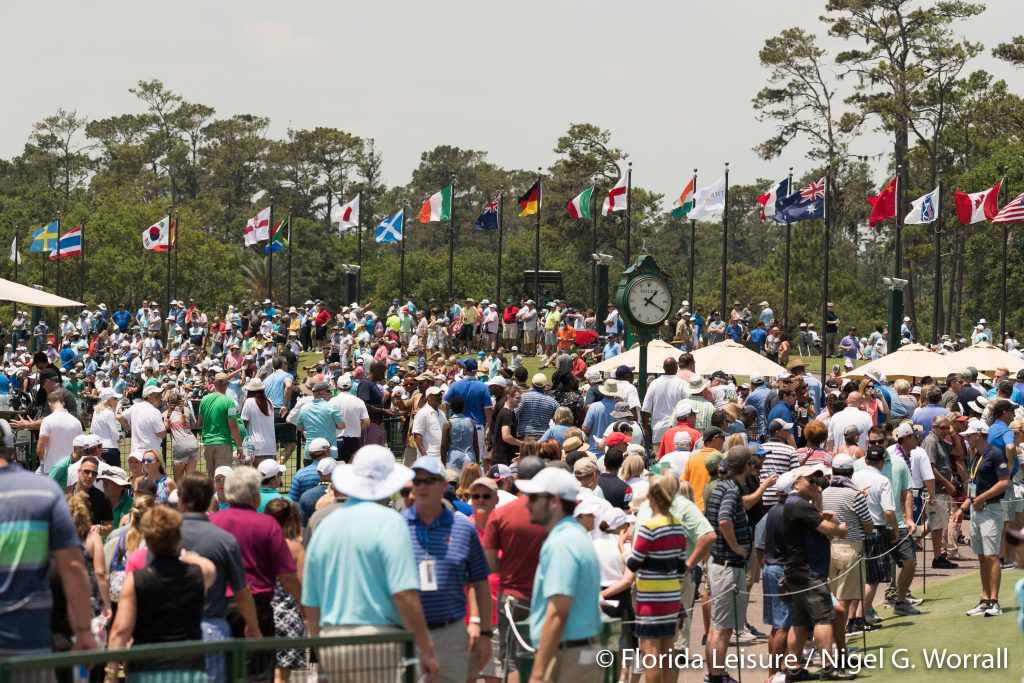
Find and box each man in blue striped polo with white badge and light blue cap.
[402,456,493,683]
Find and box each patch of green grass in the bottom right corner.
[850,570,1024,683]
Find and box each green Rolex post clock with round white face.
[615,255,672,400]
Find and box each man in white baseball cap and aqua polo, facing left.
[516,467,604,683]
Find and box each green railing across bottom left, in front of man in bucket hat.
[0,632,417,683]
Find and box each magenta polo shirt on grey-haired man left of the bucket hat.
[210,503,296,596]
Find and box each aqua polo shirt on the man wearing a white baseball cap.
[529,517,601,647]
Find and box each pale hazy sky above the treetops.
[0,0,1024,199]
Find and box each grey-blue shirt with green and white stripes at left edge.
[0,464,80,656]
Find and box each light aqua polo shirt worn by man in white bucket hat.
[302,498,417,626]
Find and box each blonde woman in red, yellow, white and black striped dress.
[626,474,686,683]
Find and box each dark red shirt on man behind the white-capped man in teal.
[483,496,548,601]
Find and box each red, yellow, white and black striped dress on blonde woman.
[626,515,686,624]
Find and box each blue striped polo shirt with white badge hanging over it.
[401,505,490,625]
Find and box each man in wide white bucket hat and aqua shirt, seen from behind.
[302,445,438,681]
